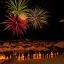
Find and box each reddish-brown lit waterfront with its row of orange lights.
[0,41,64,62]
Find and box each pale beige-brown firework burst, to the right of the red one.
[28,8,48,29]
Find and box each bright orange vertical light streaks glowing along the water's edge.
[0,52,59,61]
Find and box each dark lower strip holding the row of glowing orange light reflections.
[0,51,59,61]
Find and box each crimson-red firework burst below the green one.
[3,15,27,35]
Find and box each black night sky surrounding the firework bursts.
[0,0,64,40]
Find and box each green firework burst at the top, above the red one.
[7,0,28,15]
